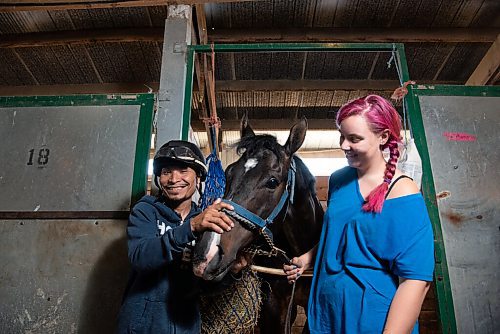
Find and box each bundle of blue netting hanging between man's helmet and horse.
[200,128,226,210]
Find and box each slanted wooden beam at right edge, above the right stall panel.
[465,34,500,86]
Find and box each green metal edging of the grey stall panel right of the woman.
[407,85,500,333]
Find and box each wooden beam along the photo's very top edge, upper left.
[0,0,262,13]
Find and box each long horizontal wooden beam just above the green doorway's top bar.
[208,28,500,43]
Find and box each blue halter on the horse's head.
[222,157,296,240]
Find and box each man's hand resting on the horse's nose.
[191,198,234,234]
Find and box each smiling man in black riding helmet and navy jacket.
[118,140,234,333]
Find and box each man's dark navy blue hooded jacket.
[118,196,200,334]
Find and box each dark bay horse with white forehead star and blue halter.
[193,116,323,334]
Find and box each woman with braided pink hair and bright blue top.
[284,95,434,333]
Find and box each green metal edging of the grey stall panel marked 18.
[0,94,155,210]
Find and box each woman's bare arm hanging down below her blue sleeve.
[384,278,430,334]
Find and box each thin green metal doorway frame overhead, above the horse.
[182,43,410,140]
